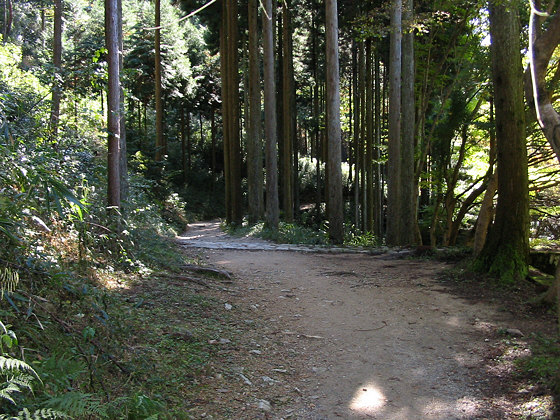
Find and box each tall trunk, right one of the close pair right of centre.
[398,0,416,245]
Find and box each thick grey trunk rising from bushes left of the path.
[105,0,121,209]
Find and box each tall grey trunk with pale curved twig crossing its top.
[262,0,279,230]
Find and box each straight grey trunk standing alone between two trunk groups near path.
[325,0,344,244]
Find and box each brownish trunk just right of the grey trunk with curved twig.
[282,0,296,222]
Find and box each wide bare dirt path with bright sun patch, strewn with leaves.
[174,221,553,420]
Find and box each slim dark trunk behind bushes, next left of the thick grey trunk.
[50,0,63,142]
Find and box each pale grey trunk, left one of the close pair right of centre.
[386,0,402,245]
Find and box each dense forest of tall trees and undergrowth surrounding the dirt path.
[0,0,560,419]
